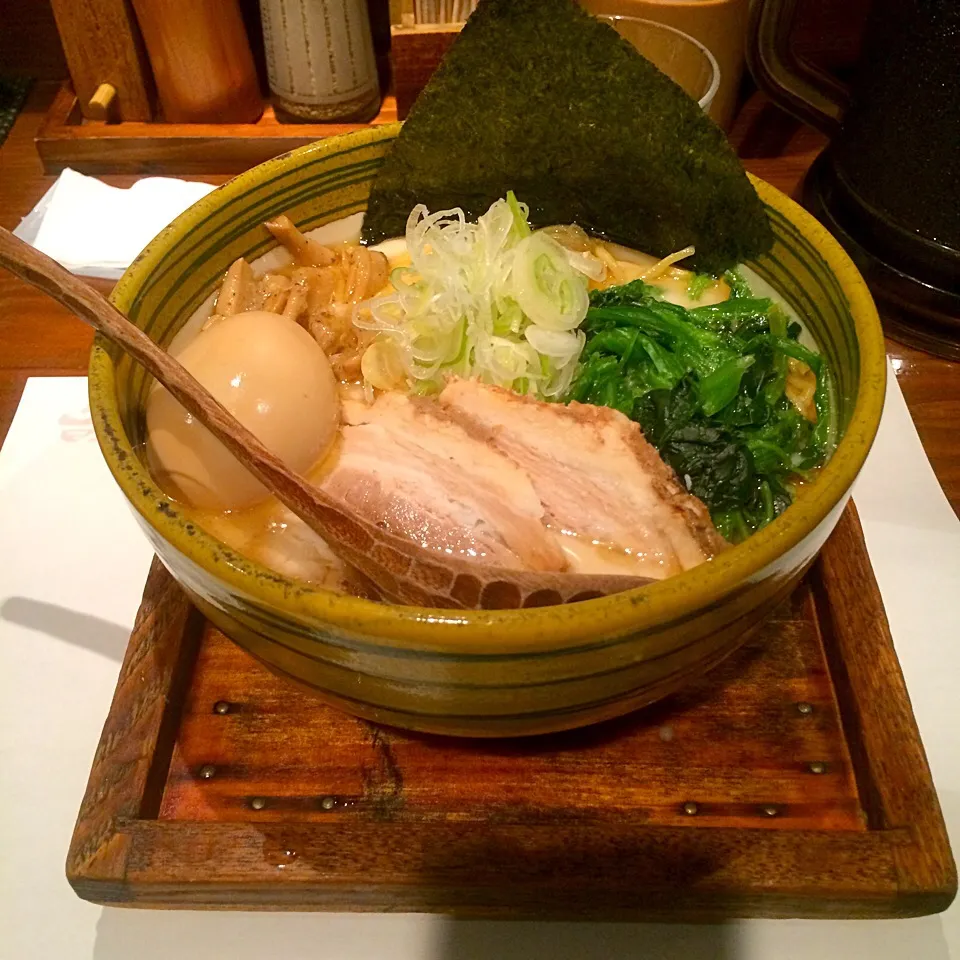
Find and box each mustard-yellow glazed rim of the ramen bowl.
[88,124,886,654]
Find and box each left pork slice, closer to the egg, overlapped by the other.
[320,393,568,571]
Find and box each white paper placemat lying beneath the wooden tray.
[0,377,960,960]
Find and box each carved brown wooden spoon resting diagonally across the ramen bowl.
[0,228,648,609]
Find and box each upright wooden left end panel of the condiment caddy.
[51,0,153,120]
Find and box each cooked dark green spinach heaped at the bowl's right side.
[566,271,835,543]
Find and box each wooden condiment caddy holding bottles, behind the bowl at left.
[36,0,459,175]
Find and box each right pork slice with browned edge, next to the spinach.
[440,380,726,579]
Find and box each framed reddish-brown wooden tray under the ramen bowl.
[67,505,957,920]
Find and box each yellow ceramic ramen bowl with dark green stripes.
[90,125,885,736]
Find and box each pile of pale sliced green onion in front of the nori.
[354,193,597,399]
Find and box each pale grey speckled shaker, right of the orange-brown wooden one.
[260,0,380,122]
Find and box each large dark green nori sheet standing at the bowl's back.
[363,0,772,273]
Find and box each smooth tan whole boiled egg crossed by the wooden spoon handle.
[147,310,340,510]
